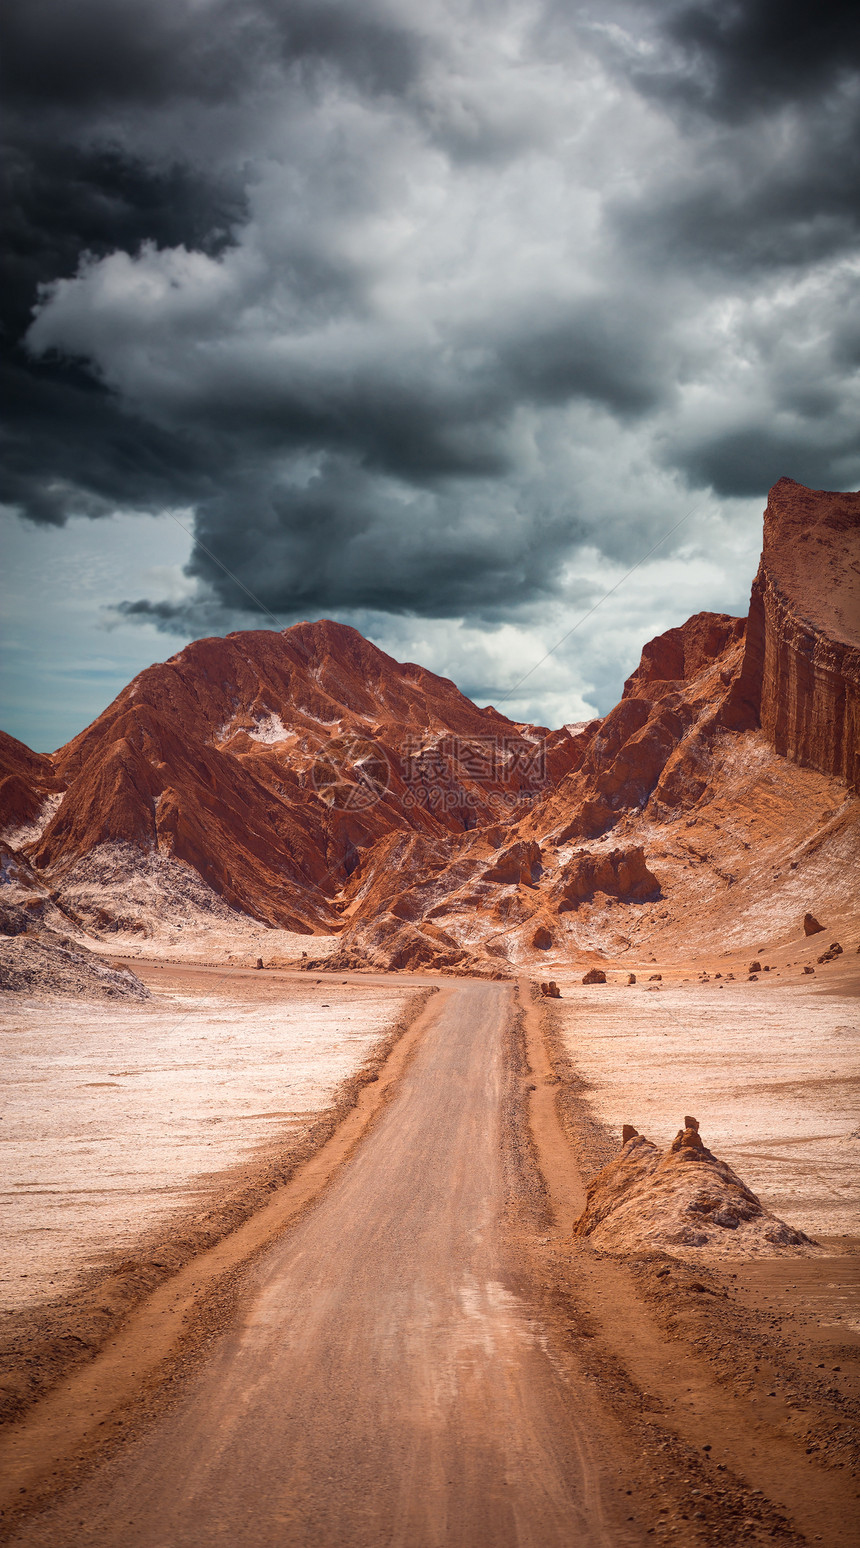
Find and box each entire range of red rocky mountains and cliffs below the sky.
[0,478,860,972]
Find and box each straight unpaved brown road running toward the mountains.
[15,981,620,1548]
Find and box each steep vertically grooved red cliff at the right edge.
[730,478,860,791]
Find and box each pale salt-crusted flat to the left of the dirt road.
[0,983,416,1308]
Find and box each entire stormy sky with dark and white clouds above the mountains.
[0,0,860,751]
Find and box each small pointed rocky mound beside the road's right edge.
[574,1118,815,1257]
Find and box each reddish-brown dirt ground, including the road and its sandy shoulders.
[0,966,860,1548]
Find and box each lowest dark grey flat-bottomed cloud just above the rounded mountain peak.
[114,457,585,630]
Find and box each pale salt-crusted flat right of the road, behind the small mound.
[554,978,860,1255]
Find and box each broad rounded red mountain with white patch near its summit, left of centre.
[0,621,563,930]
